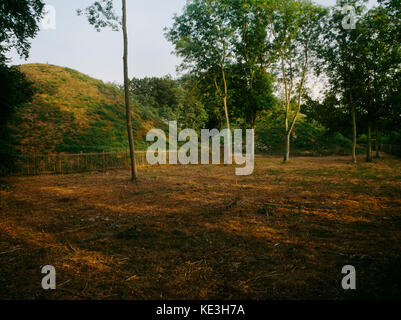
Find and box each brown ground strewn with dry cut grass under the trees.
[0,156,401,299]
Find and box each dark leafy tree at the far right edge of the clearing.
[357,2,401,162]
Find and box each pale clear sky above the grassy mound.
[9,0,372,83]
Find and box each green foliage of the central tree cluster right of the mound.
[166,0,326,157]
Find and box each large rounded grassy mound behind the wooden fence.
[11,64,163,153]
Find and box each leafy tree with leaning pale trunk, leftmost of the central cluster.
[166,0,234,129]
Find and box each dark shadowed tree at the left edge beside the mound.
[0,0,44,173]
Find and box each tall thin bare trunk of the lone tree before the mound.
[122,0,138,181]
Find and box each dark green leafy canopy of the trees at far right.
[305,0,401,161]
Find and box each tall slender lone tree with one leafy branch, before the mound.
[77,0,138,180]
